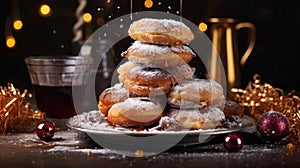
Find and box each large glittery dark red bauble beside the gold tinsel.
[257,111,290,142]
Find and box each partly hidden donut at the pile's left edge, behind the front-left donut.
[98,83,130,116]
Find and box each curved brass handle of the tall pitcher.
[235,22,256,65]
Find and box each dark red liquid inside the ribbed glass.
[33,85,85,119]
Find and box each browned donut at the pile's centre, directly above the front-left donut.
[124,68,175,96]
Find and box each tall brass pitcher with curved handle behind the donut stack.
[206,18,256,95]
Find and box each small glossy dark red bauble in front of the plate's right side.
[224,134,243,152]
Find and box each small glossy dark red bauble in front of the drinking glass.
[36,121,55,141]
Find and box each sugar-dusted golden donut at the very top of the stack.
[128,18,194,45]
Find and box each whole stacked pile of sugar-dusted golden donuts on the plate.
[98,18,237,129]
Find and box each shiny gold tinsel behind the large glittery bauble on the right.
[231,74,300,144]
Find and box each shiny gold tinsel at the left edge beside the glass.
[0,83,45,134]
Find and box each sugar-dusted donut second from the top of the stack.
[121,41,195,68]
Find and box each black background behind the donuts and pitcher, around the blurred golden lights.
[0,0,300,92]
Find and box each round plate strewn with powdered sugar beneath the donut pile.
[66,111,255,146]
